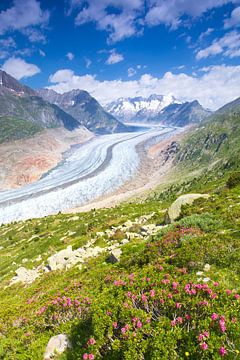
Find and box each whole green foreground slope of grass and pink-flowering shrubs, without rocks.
[0,162,240,359]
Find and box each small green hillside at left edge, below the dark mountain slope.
[0,116,43,144]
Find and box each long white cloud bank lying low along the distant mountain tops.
[47,65,240,109]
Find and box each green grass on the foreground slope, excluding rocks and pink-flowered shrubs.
[0,165,240,360]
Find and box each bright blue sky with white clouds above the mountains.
[0,0,240,109]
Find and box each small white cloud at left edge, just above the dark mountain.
[2,57,41,80]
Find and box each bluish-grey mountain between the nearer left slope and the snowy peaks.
[38,89,126,134]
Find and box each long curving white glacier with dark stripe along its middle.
[0,126,177,223]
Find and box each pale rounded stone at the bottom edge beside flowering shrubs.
[44,334,71,360]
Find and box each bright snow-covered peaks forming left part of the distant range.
[105,94,181,121]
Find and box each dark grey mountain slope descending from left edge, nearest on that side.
[0,70,79,135]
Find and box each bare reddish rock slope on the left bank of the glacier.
[0,129,92,191]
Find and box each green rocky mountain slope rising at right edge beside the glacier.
[177,95,240,169]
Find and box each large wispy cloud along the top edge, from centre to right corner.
[69,0,239,43]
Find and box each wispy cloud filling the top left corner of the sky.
[0,0,49,35]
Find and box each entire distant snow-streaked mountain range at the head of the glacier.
[105,94,211,126]
